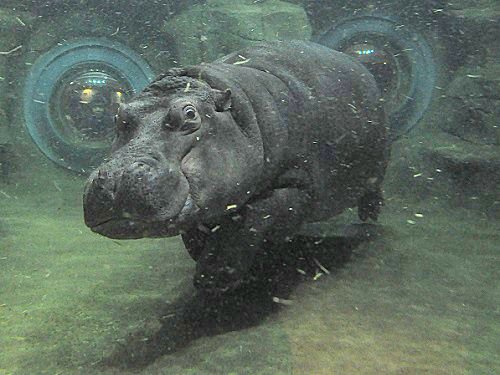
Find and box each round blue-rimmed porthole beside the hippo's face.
[24,39,154,172]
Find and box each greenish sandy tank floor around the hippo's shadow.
[0,166,500,375]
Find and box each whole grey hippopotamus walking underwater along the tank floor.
[84,41,389,293]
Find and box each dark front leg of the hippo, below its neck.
[190,188,309,292]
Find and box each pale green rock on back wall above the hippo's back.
[163,0,311,66]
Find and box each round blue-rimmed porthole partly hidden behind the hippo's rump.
[318,15,436,139]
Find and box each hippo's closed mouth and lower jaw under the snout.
[90,194,199,239]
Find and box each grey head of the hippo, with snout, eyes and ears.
[84,71,263,239]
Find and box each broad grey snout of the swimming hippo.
[84,157,189,238]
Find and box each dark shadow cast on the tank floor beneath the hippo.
[101,224,380,369]
